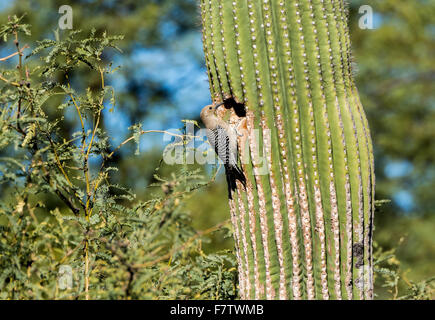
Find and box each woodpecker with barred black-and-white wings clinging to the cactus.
[201,103,246,199]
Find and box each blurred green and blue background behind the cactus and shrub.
[0,0,435,297]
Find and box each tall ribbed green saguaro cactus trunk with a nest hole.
[201,0,374,299]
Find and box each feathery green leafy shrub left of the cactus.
[0,17,237,299]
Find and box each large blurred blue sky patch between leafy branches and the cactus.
[105,32,211,150]
